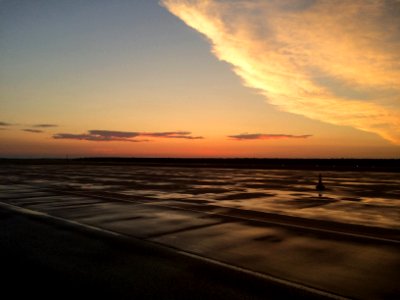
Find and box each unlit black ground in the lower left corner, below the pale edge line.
[0,208,317,299]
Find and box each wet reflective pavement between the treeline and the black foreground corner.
[0,165,400,298]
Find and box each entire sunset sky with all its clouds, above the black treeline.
[0,0,400,158]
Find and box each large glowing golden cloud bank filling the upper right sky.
[162,0,400,144]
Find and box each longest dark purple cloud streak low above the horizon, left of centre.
[53,130,203,142]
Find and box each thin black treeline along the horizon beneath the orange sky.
[0,157,400,172]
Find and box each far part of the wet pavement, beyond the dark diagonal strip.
[0,165,400,228]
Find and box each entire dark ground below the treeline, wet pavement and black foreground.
[0,163,400,299]
